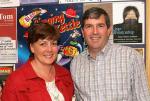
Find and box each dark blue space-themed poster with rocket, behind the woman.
[16,4,83,69]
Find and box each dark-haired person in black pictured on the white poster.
[113,6,142,43]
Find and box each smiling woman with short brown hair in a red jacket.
[2,23,74,101]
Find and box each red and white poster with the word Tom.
[0,8,18,63]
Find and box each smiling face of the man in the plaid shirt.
[82,15,111,50]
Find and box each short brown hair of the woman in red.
[27,22,60,56]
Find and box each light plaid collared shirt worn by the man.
[70,43,150,101]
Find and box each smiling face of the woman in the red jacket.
[30,39,58,65]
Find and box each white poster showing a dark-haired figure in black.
[113,2,145,44]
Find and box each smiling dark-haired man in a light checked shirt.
[70,7,150,101]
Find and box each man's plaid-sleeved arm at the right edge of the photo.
[132,52,150,101]
